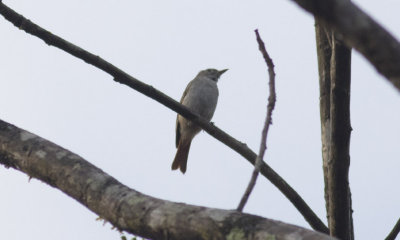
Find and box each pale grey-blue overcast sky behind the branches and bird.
[0,0,400,240]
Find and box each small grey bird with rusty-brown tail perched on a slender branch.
[171,68,228,174]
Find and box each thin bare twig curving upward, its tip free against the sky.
[237,29,276,212]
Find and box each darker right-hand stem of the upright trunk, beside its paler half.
[328,33,352,240]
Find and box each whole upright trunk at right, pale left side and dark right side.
[316,20,353,240]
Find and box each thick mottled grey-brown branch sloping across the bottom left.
[0,120,333,240]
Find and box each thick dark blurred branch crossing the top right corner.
[292,0,400,90]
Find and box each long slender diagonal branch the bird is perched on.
[0,2,328,233]
